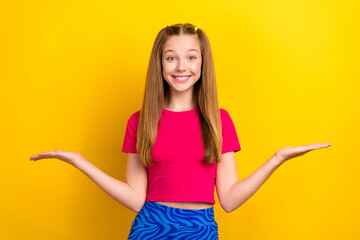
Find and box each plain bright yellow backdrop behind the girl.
[0,0,360,240]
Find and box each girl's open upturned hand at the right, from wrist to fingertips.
[275,143,331,163]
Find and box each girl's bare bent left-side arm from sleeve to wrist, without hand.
[73,153,148,212]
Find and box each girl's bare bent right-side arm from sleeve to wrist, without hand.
[216,152,281,213]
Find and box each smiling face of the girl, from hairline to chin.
[162,35,202,92]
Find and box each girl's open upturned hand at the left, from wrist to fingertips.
[30,150,84,165]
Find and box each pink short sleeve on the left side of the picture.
[122,111,139,153]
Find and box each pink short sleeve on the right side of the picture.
[220,109,241,154]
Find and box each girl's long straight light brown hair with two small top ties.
[136,23,222,166]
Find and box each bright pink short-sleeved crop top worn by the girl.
[122,108,241,204]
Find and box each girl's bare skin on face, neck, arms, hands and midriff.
[30,35,331,213]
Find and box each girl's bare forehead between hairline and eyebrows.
[163,35,200,53]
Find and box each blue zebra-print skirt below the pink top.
[128,201,219,240]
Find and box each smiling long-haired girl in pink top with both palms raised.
[30,23,330,240]
